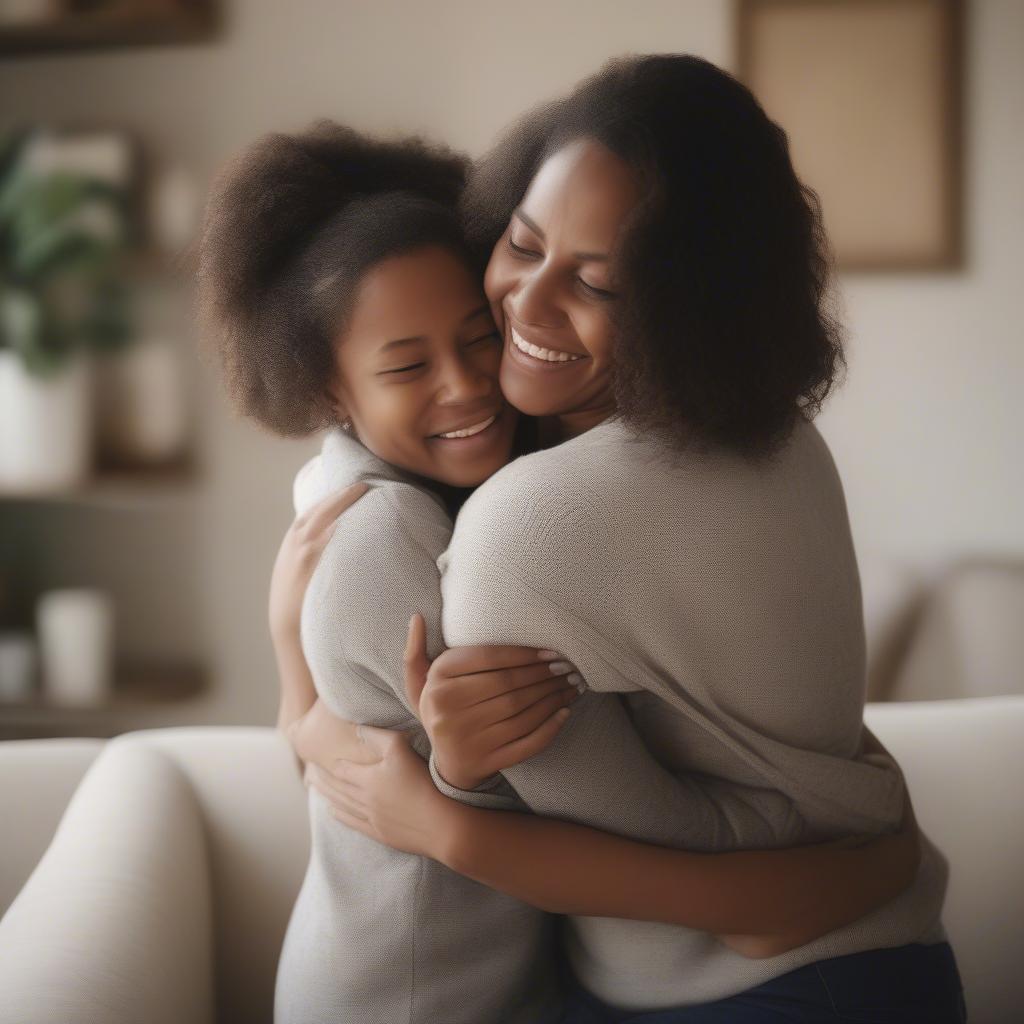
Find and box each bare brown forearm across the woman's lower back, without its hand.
[436,778,919,956]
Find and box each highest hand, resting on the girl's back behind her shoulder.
[269,483,370,648]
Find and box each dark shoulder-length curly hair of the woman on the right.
[461,54,845,456]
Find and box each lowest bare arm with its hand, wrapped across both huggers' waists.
[309,679,919,957]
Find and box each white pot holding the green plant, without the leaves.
[0,350,92,492]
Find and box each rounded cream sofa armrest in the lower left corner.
[0,739,214,1024]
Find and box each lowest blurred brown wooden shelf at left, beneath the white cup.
[0,665,207,740]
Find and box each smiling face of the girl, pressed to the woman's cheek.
[328,247,516,487]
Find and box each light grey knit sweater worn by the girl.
[274,430,561,1024]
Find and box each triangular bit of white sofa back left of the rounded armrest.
[0,739,104,918]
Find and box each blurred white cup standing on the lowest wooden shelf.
[36,588,114,707]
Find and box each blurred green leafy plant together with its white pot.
[0,132,129,490]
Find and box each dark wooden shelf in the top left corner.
[0,2,219,57]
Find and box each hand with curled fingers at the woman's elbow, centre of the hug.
[404,614,584,790]
